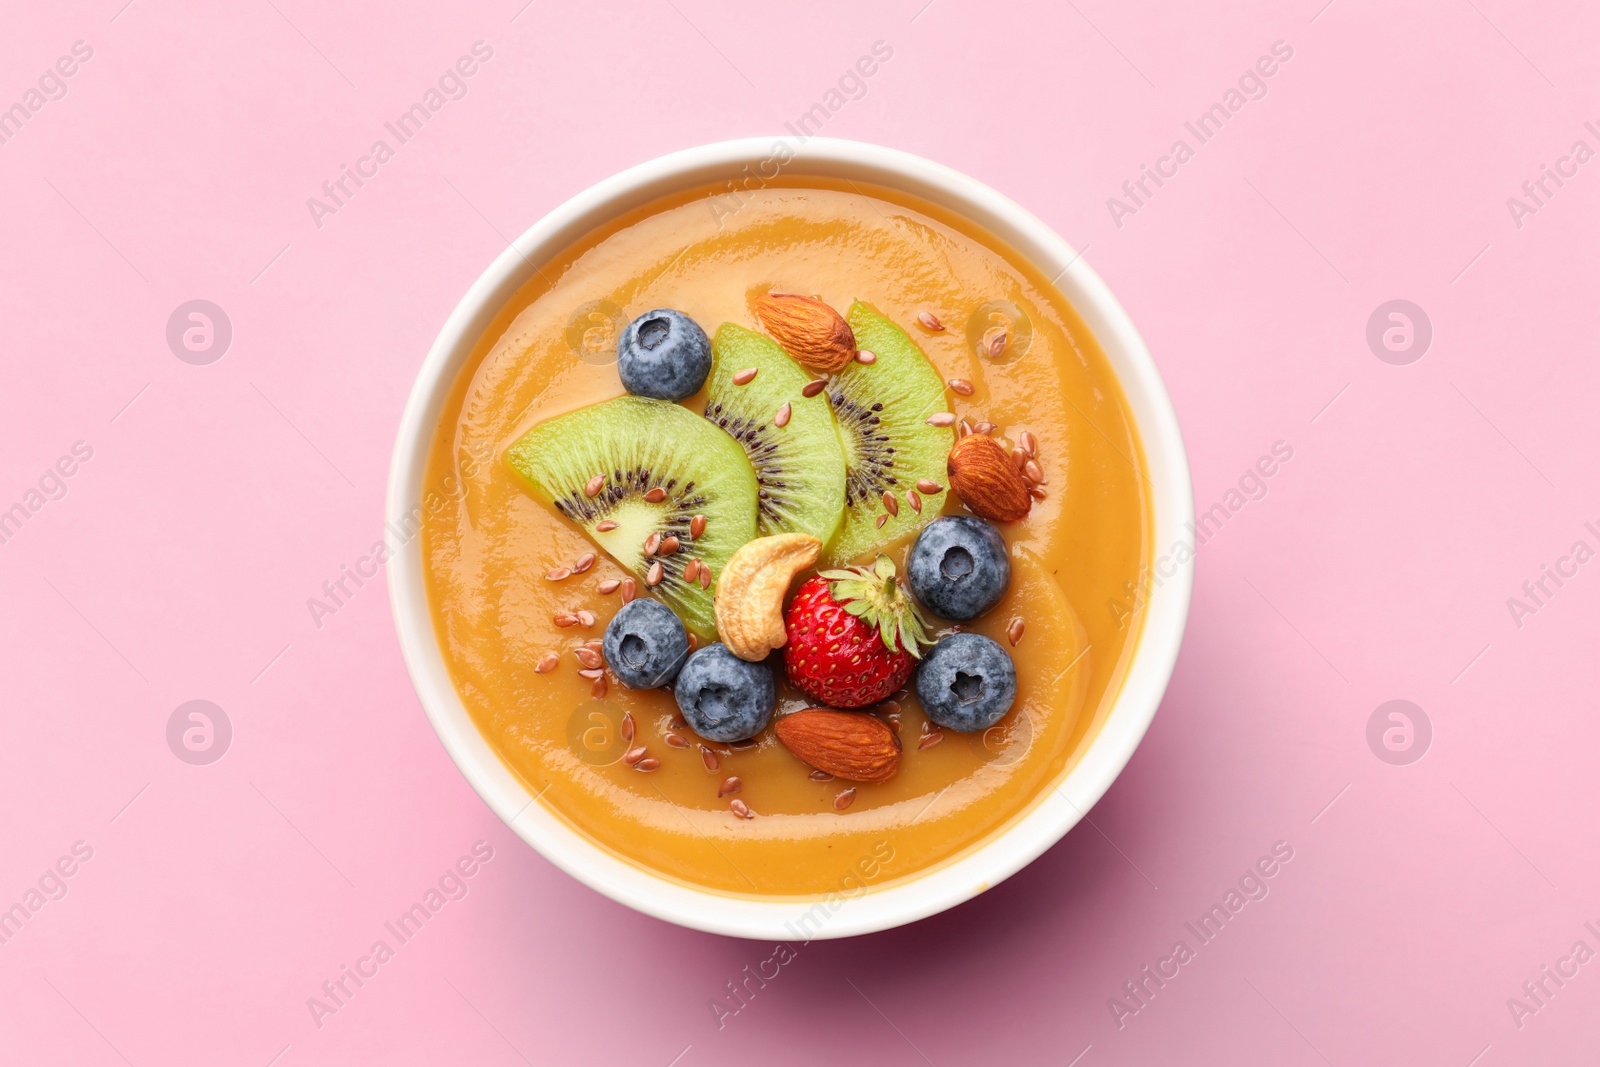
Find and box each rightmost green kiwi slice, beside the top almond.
[826,301,955,565]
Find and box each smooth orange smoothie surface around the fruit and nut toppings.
[422,179,1150,899]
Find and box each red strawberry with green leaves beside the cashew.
[784,555,928,707]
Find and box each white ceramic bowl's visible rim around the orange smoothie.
[386,138,1194,941]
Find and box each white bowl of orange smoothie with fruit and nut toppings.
[387,139,1192,939]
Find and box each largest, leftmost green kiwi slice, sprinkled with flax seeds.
[506,397,757,640]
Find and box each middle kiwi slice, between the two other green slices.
[706,323,845,544]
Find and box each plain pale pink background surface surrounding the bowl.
[0,0,1600,1067]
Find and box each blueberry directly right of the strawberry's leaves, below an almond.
[906,515,1011,622]
